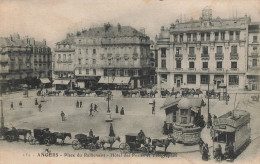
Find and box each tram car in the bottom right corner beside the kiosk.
[211,110,251,160]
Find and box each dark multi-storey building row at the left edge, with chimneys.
[0,34,52,92]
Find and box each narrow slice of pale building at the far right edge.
[246,22,260,90]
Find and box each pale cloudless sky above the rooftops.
[0,0,260,47]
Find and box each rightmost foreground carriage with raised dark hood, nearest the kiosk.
[119,133,152,153]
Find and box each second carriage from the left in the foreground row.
[28,128,57,146]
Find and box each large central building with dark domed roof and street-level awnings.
[54,23,150,88]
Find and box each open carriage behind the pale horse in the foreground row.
[72,134,100,151]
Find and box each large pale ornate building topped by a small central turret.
[157,8,251,89]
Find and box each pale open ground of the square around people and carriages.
[0,90,260,161]
